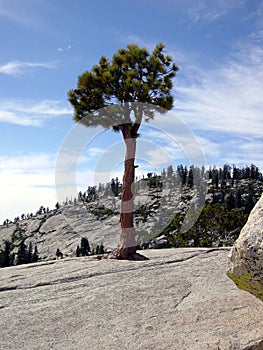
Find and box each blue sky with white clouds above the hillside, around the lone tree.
[0,0,263,222]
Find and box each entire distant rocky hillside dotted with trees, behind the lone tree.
[0,165,263,266]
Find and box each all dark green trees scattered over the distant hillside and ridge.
[0,164,263,267]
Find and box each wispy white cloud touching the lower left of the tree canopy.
[0,100,72,127]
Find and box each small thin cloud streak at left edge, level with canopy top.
[0,61,55,75]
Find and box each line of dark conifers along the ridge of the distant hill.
[3,164,263,226]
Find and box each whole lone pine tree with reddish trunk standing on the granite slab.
[68,43,178,259]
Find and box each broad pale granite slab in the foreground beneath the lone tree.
[0,248,263,350]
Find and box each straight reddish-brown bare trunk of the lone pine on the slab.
[116,125,146,260]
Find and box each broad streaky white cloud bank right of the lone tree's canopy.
[171,32,263,167]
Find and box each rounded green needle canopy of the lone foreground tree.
[68,43,179,131]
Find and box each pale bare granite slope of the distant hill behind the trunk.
[0,188,183,260]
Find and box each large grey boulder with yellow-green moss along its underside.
[227,191,263,300]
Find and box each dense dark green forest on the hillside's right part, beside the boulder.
[146,164,263,247]
